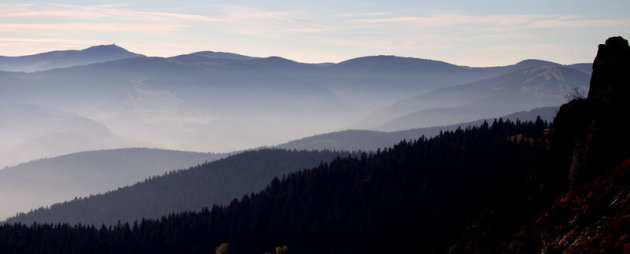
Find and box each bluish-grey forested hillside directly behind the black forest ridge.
[7,149,348,225]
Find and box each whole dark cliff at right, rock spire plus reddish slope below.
[451,37,630,253]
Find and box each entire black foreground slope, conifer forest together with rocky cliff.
[0,37,630,253]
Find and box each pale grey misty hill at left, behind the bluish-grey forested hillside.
[0,148,225,219]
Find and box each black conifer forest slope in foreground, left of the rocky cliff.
[0,120,549,253]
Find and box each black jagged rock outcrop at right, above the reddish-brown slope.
[550,37,630,188]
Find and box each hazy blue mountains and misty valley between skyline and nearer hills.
[0,45,590,167]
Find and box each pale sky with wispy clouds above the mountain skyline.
[0,0,630,66]
